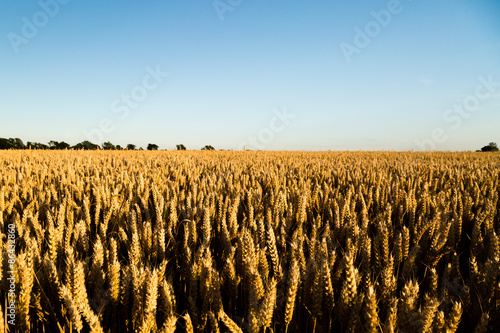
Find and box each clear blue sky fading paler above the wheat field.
[0,0,500,150]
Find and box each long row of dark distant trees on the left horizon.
[0,138,219,150]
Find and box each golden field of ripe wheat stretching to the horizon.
[0,150,500,333]
